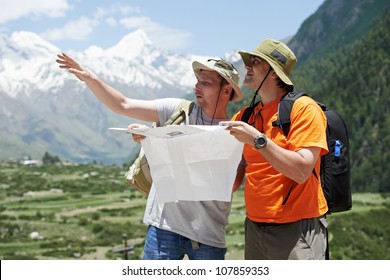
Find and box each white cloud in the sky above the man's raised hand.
[39,17,99,41]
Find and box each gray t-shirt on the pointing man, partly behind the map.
[144,98,231,248]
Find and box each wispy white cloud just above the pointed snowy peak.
[120,16,191,49]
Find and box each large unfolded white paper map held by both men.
[110,125,244,203]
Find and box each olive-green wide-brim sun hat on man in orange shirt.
[238,38,297,86]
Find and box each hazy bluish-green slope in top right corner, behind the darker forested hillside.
[289,0,390,63]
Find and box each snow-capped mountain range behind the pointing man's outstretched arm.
[0,30,219,162]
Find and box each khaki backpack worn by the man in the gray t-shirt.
[125,99,194,195]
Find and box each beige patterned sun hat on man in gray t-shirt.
[192,59,243,102]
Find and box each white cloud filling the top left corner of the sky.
[0,0,70,23]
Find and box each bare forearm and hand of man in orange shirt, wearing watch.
[221,121,321,184]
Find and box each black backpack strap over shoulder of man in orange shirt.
[272,91,308,137]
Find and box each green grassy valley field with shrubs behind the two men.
[0,165,390,260]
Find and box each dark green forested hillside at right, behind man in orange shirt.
[294,10,390,192]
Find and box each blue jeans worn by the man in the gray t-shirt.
[143,226,226,260]
